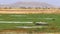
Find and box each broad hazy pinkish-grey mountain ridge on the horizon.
[0,2,57,8]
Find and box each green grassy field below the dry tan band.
[0,14,60,30]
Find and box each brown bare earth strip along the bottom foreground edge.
[0,29,60,34]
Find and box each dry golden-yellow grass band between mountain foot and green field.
[0,9,60,14]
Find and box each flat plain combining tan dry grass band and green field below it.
[0,9,60,32]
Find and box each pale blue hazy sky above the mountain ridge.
[0,0,60,6]
